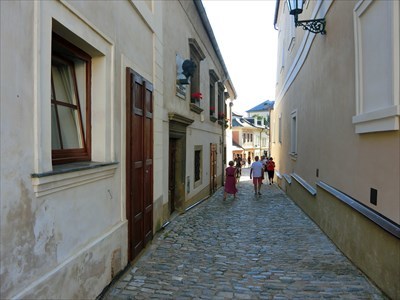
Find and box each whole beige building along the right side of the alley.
[271,0,400,299]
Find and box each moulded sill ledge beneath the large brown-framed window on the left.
[31,162,118,197]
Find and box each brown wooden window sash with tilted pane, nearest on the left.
[51,33,91,164]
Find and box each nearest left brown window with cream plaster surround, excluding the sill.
[47,18,113,169]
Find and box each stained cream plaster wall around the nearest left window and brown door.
[0,1,163,299]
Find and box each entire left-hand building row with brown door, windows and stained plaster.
[0,0,236,299]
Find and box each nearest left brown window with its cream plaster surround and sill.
[32,16,116,193]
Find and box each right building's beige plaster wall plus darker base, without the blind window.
[272,1,400,299]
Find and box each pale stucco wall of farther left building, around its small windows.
[163,1,234,204]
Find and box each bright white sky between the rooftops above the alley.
[202,0,278,114]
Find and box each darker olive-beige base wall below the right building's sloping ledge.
[284,180,400,299]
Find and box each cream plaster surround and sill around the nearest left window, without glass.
[32,1,116,197]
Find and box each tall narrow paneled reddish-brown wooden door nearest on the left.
[126,68,153,260]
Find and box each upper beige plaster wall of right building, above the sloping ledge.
[272,1,400,224]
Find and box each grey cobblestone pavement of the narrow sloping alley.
[103,170,386,300]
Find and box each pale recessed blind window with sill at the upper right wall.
[353,0,400,133]
